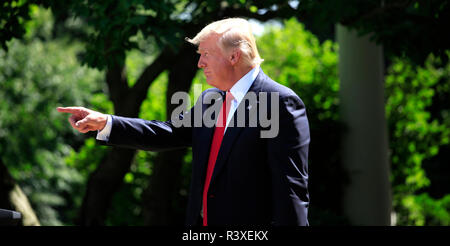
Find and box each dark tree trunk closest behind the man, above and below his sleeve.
[142,44,197,225]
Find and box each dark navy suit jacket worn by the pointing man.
[100,70,310,226]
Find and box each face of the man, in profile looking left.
[197,35,232,90]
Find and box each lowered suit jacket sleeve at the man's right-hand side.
[267,94,310,225]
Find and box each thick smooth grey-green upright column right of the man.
[337,25,391,226]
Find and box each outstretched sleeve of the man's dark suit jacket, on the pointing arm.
[99,115,192,151]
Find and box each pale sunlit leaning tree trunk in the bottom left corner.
[0,159,40,226]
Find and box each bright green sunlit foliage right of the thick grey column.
[386,52,450,225]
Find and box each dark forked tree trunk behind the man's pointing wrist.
[75,45,174,225]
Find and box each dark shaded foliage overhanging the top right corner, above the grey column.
[296,0,450,65]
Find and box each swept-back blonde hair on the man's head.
[186,18,264,66]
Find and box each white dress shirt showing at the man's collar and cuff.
[97,66,259,141]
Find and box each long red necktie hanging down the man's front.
[203,91,234,226]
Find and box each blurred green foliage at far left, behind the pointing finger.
[0,9,103,225]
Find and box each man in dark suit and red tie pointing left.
[58,18,310,226]
